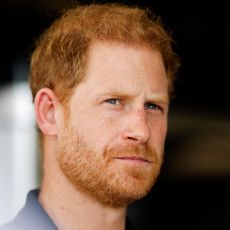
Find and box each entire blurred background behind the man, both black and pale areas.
[0,0,230,230]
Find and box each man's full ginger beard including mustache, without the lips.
[57,122,162,208]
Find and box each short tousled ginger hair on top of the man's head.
[30,3,179,102]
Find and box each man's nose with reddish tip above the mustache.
[123,110,150,144]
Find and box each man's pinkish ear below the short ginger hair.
[34,88,59,135]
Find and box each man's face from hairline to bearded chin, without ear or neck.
[57,41,168,207]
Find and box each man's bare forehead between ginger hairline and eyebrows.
[73,41,168,99]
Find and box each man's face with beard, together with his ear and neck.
[35,41,169,230]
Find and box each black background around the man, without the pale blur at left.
[0,0,230,230]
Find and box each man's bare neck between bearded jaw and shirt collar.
[39,137,126,230]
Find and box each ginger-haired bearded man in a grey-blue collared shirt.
[0,4,179,230]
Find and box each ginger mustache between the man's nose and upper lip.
[104,144,159,164]
